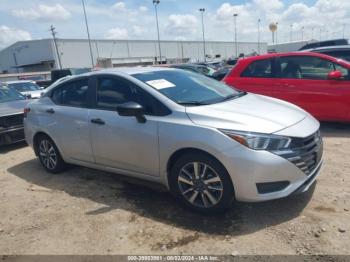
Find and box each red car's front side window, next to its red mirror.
[280,56,334,80]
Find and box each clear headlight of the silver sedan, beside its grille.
[219,129,291,151]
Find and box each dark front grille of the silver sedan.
[278,131,323,175]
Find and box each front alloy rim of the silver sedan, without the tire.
[177,162,223,208]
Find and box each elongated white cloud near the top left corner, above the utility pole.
[12,4,71,21]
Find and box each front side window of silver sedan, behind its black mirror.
[96,77,170,116]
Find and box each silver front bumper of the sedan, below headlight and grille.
[220,137,323,202]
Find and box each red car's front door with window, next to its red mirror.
[275,55,349,120]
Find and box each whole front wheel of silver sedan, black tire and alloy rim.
[169,153,234,213]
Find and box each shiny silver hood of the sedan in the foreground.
[186,94,308,134]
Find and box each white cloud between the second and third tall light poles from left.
[165,14,199,37]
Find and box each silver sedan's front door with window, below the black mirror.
[89,75,159,176]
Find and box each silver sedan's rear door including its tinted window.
[40,77,93,162]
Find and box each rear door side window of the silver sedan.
[51,78,88,107]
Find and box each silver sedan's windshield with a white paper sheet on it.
[133,70,242,105]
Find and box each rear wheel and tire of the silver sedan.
[35,135,67,174]
